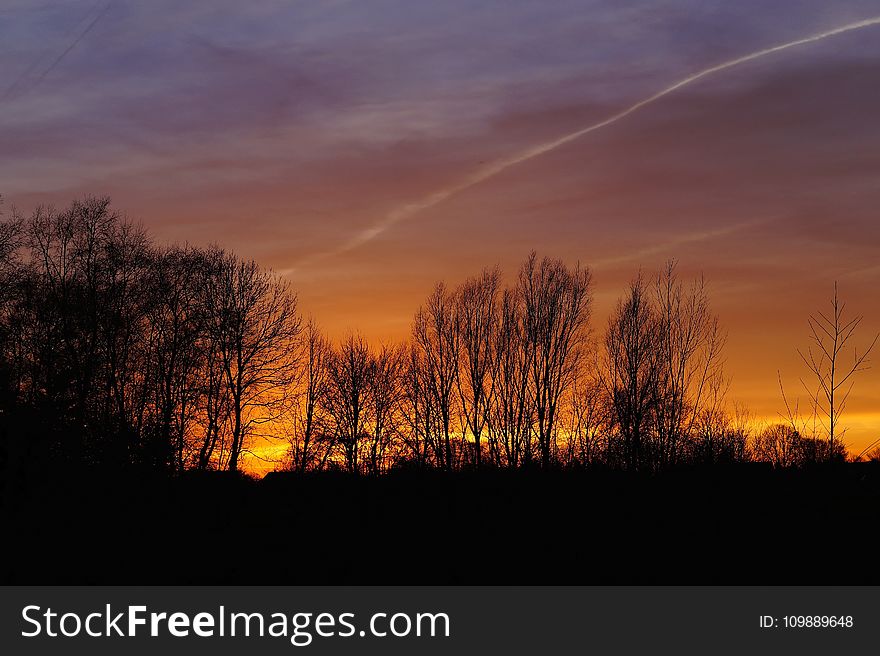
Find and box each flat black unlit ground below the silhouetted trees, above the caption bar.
[0,464,880,584]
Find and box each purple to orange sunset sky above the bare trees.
[0,0,880,458]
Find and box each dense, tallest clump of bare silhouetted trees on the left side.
[0,198,300,470]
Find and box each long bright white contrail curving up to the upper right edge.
[287,16,880,272]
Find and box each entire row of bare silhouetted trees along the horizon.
[0,198,845,474]
